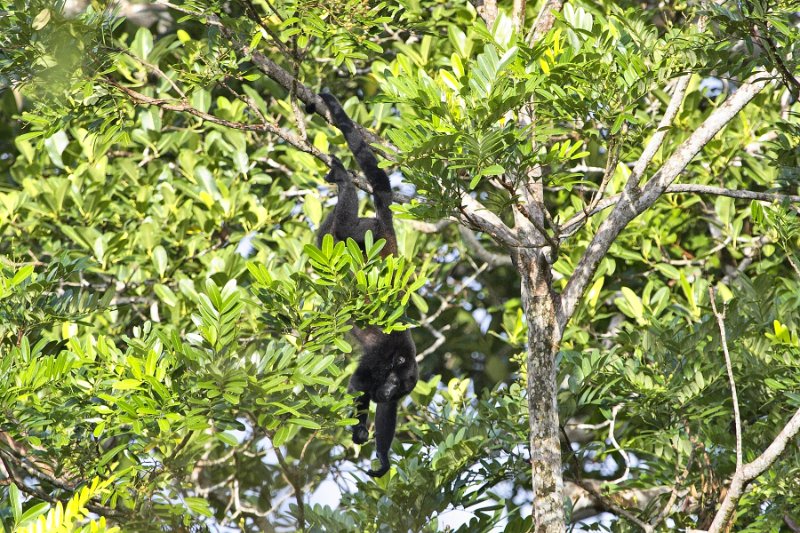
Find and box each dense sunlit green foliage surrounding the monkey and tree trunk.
[0,0,800,531]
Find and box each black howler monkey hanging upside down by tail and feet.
[310,93,419,477]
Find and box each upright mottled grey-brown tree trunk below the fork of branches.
[517,249,565,533]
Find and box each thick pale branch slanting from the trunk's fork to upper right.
[558,71,769,329]
